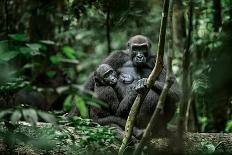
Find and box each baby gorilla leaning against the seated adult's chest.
[90,64,142,138]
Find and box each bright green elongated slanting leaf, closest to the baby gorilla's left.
[74,95,89,118]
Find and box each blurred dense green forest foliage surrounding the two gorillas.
[0,0,232,153]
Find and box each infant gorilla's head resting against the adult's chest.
[94,64,118,86]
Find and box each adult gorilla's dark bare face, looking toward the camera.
[130,43,149,66]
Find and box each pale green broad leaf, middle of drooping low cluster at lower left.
[23,109,38,125]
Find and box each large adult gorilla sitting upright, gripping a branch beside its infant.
[82,35,180,136]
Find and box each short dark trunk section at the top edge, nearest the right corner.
[213,0,222,32]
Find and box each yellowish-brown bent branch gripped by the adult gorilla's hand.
[118,0,169,155]
